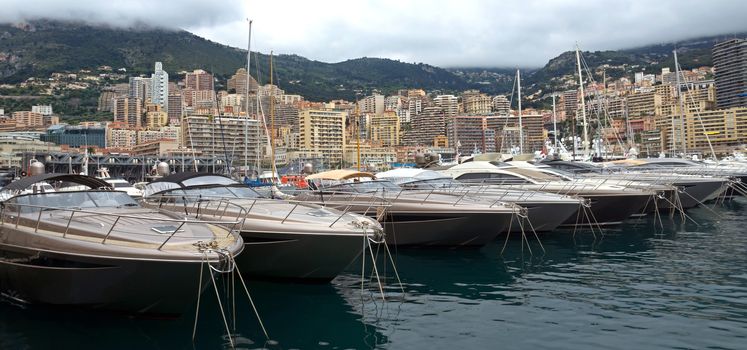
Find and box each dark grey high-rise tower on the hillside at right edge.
[713,39,747,108]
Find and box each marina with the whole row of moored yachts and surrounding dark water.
[0,159,747,349]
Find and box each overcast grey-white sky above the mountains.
[0,0,747,67]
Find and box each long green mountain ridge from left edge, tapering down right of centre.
[0,20,469,100]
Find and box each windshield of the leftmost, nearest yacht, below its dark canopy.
[11,191,139,213]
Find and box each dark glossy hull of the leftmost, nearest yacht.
[0,244,210,315]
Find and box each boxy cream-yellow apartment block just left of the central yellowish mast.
[298,109,347,166]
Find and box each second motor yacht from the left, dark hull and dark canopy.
[143,172,383,282]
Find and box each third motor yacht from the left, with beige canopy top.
[296,170,521,246]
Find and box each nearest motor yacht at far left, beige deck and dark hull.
[0,174,243,315]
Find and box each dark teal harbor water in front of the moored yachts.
[0,198,747,349]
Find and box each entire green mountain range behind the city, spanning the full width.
[0,20,744,102]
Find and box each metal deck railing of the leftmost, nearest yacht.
[0,203,241,250]
